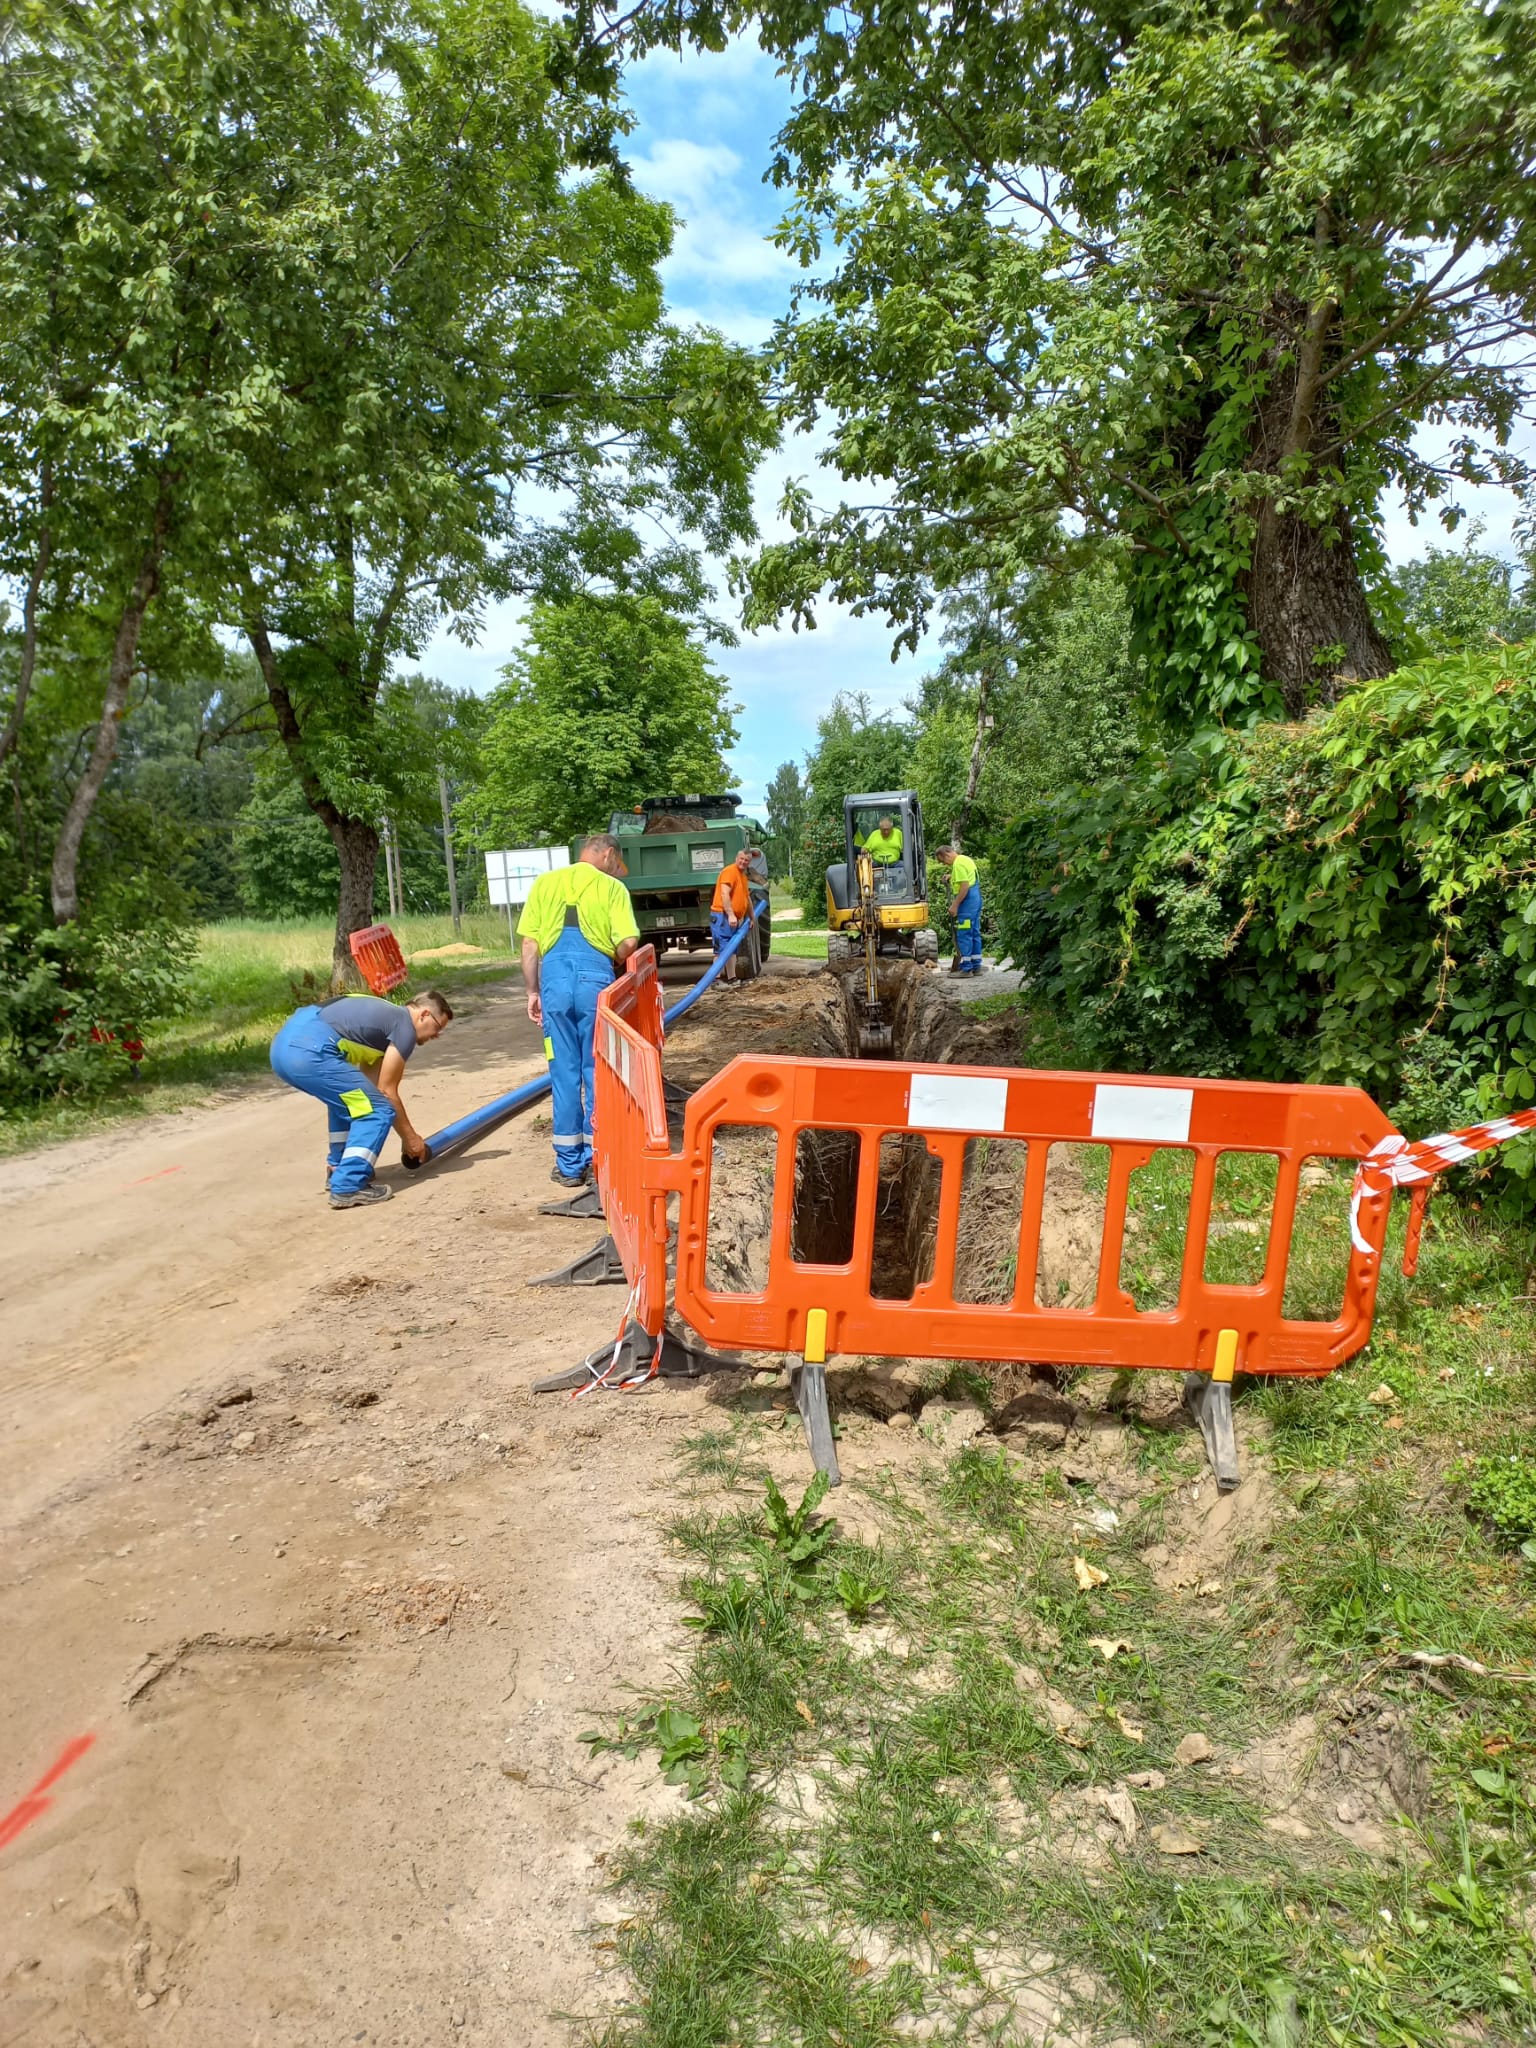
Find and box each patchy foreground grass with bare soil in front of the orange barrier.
[590,1182,1536,2048]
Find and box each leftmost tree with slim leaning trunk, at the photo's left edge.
[0,0,328,922]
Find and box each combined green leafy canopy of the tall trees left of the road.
[0,0,774,961]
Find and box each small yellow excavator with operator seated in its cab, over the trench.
[827,788,938,1059]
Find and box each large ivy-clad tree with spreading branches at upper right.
[622,0,1536,719]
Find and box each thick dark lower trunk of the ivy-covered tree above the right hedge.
[1247,499,1393,719]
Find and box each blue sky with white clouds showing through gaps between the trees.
[422,39,1513,807]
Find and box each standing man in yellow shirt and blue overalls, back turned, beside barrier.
[518,831,639,1188]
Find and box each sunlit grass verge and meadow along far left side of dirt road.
[0,911,512,1155]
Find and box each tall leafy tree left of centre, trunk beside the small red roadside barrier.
[222,0,770,973]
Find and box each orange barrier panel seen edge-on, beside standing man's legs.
[592,946,672,1335]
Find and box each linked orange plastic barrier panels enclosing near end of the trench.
[594,948,1427,1380]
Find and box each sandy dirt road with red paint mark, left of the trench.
[0,961,825,2048]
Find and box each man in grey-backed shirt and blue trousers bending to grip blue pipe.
[272,989,453,1208]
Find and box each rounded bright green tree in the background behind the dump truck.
[463,598,735,848]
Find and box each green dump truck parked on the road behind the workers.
[571,797,772,981]
